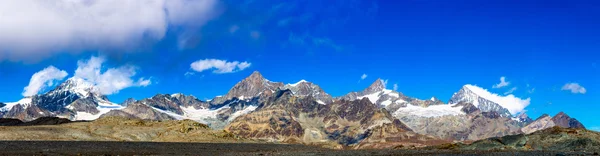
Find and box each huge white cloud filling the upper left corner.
[0,0,219,60]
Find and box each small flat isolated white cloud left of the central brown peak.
[190,59,252,74]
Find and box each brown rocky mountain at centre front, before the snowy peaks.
[226,90,446,148]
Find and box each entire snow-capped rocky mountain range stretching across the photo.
[0,72,585,148]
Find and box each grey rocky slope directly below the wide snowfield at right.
[394,102,522,141]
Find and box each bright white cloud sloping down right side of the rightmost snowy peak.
[466,85,531,115]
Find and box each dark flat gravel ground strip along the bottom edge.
[0,141,594,155]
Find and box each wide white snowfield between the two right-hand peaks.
[394,104,465,117]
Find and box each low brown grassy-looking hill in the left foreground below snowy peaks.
[0,117,248,143]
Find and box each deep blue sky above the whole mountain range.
[0,0,600,128]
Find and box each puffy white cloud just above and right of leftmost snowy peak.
[74,57,152,95]
